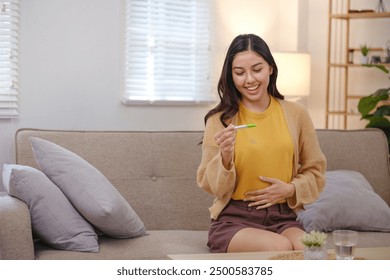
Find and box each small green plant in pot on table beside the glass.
[301,231,328,260]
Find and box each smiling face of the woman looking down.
[232,50,272,108]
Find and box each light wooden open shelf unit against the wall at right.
[326,0,390,129]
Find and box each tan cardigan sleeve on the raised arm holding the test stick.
[197,114,236,199]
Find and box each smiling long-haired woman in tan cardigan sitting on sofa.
[197,34,326,252]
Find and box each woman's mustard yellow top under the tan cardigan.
[232,97,294,202]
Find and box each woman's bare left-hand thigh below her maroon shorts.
[227,228,296,252]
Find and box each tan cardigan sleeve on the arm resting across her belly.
[287,102,326,209]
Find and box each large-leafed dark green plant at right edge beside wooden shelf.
[358,64,390,150]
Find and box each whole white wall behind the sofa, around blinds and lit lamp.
[0,0,340,189]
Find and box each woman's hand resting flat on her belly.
[244,176,295,209]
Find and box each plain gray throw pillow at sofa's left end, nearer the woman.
[30,137,145,238]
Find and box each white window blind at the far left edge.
[0,0,19,118]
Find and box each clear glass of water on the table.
[333,230,358,260]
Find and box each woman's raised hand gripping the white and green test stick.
[215,124,236,169]
